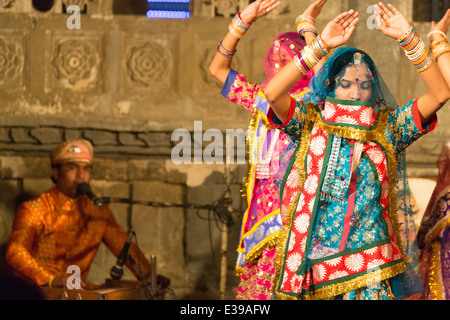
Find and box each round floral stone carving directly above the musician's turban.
[52,39,100,91]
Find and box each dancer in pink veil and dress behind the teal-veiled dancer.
[210,0,326,300]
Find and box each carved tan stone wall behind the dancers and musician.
[0,0,449,299]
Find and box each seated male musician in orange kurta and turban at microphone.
[6,140,170,287]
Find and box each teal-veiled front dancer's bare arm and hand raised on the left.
[264,10,359,122]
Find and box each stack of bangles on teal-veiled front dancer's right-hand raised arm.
[397,27,433,72]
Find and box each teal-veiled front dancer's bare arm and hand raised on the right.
[375,2,450,123]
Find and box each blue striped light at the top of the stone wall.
[147,0,191,19]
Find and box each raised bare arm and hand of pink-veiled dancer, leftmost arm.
[209,0,281,83]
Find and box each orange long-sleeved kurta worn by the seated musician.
[6,187,150,285]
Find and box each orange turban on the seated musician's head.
[50,139,94,165]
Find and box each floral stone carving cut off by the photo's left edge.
[0,38,24,85]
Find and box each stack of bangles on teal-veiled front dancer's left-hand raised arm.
[294,35,329,75]
